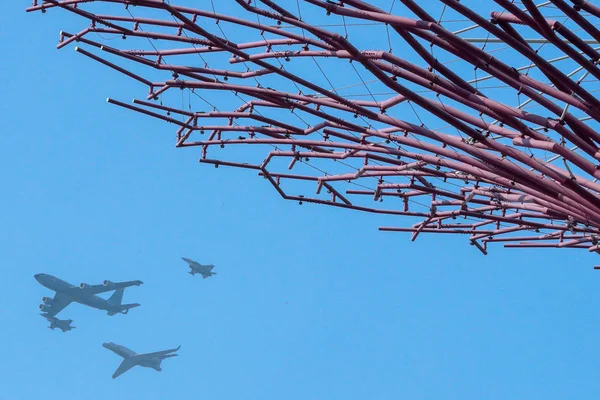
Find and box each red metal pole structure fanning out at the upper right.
[28,0,600,254]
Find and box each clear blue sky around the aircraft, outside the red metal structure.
[0,1,600,400]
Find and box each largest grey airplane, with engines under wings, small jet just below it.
[34,274,144,317]
